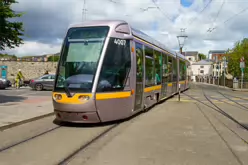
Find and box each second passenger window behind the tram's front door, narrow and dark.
[154,50,162,85]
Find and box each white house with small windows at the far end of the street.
[191,60,213,81]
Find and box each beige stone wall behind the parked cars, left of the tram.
[0,61,57,81]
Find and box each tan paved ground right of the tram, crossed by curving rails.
[70,85,248,165]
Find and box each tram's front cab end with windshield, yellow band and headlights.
[53,23,132,123]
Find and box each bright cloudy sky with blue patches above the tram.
[1,0,248,56]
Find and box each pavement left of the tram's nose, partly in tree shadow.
[0,87,53,130]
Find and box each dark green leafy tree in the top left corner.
[0,0,24,50]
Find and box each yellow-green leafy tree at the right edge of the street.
[227,38,248,78]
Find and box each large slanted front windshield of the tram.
[55,27,109,92]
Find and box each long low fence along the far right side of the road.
[196,76,248,89]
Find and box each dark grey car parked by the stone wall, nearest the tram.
[29,74,55,91]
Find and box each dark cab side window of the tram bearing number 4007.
[97,38,131,92]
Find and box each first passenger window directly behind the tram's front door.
[145,46,155,87]
